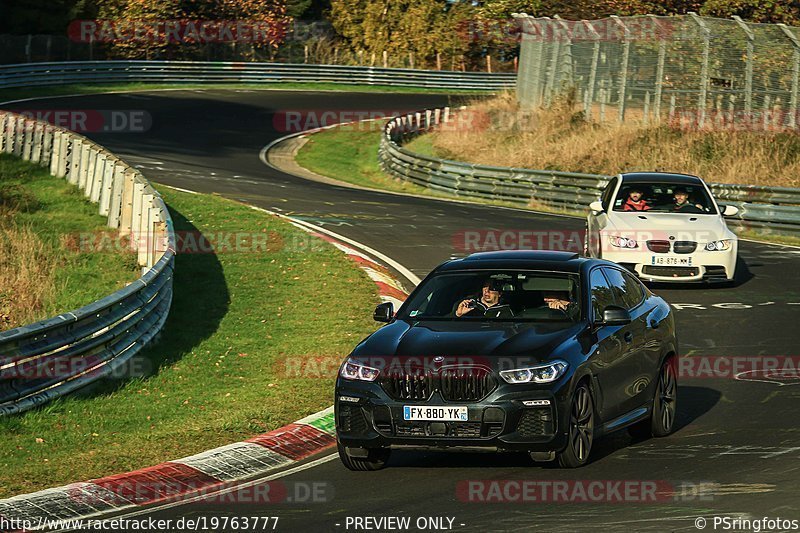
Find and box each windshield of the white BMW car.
[614,183,717,215]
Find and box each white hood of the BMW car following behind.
[605,212,730,242]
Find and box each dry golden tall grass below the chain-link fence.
[431,94,800,187]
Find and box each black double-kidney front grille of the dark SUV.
[379,367,497,402]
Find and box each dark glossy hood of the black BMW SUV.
[351,320,585,361]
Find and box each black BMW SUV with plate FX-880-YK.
[334,251,678,470]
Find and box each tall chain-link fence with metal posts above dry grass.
[515,13,800,130]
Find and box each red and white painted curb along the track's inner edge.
[0,206,412,531]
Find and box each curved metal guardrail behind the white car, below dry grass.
[378,107,800,237]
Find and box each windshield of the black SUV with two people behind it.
[398,270,581,322]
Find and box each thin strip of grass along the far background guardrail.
[0,82,491,102]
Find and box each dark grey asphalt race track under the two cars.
[6,90,800,531]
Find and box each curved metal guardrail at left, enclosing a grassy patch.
[0,111,175,416]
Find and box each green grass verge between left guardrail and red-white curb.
[0,187,378,497]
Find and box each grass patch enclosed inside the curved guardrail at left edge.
[0,154,139,330]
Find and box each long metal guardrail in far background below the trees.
[0,60,516,90]
